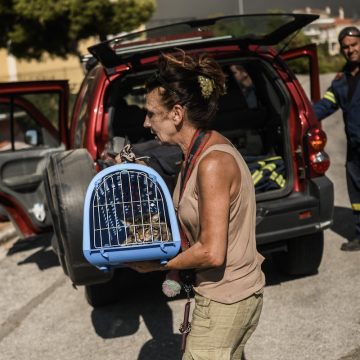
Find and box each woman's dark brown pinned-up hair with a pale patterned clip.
[146,50,225,129]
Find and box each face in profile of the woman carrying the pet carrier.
[144,88,177,144]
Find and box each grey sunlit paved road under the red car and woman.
[0,74,360,360]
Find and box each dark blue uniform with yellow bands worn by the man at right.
[314,66,360,239]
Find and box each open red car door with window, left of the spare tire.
[0,81,69,237]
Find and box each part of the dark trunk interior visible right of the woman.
[214,57,292,200]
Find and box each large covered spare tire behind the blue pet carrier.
[45,149,112,285]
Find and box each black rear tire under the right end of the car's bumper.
[273,231,324,275]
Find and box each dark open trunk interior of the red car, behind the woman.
[103,57,292,200]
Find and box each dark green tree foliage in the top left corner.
[0,0,155,60]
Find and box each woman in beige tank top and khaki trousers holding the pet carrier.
[130,52,265,359]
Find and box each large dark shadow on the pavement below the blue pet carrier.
[91,272,185,360]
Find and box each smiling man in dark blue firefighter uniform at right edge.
[314,26,360,251]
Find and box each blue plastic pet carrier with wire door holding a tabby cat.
[83,163,181,270]
